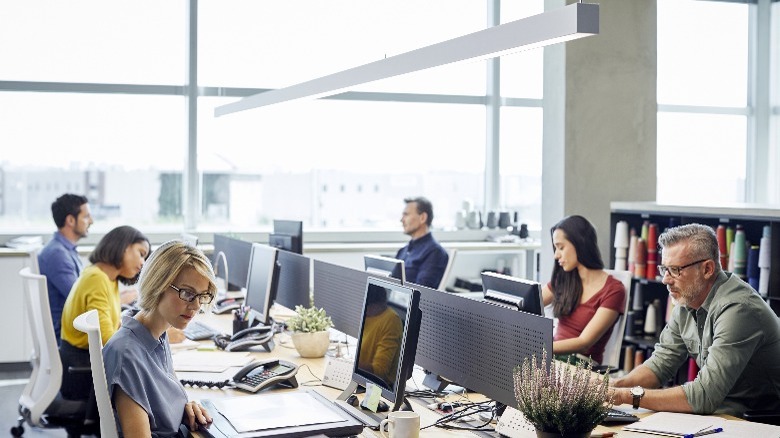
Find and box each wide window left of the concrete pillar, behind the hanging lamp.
[0,0,543,236]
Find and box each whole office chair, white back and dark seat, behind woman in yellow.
[11,267,95,437]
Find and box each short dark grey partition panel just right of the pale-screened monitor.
[276,251,311,309]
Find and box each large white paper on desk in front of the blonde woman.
[212,392,342,433]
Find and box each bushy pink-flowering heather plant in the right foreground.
[514,350,612,438]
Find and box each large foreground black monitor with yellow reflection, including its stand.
[337,277,422,426]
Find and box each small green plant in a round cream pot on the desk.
[287,306,333,357]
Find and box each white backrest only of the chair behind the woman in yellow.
[17,266,62,426]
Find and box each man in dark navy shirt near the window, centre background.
[395,197,449,289]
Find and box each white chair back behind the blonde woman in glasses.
[73,309,119,438]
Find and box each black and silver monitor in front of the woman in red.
[482,272,543,315]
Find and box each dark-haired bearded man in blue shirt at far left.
[38,193,93,340]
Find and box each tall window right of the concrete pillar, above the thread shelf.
[657,0,780,205]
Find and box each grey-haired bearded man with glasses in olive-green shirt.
[613,224,780,416]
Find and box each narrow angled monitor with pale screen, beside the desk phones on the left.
[244,243,280,326]
